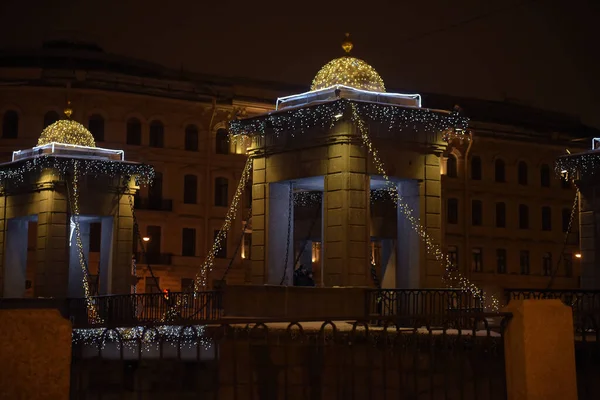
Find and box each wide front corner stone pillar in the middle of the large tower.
[323,143,370,286]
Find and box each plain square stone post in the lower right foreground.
[504,300,577,400]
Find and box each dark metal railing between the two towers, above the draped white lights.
[68,291,222,328]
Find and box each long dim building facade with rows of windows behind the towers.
[0,43,600,295]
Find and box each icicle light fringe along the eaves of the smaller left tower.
[0,155,154,185]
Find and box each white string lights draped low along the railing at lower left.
[72,325,212,351]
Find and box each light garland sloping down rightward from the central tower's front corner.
[351,104,499,311]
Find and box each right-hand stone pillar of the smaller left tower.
[110,193,133,294]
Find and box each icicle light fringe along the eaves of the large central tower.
[229,99,469,140]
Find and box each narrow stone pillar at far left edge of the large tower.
[250,157,267,285]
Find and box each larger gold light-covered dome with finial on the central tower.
[310,33,385,93]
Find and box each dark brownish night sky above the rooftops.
[0,0,600,127]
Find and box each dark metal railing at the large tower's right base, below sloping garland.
[367,289,483,326]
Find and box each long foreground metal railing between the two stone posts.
[71,314,510,400]
